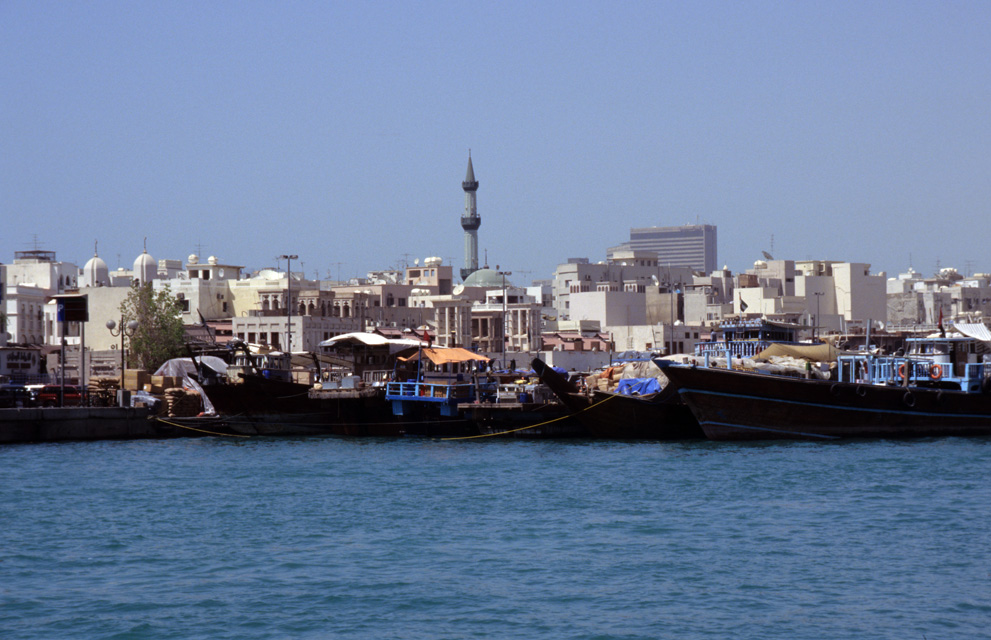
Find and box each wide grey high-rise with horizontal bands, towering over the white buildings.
[606,224,718,273]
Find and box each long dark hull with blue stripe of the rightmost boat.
[658,362,991,440]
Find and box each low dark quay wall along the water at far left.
[0,407,172,445]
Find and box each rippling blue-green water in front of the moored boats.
[0,438,991,640]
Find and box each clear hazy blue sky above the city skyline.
[0,0,991,283]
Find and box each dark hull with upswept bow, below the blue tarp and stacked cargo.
[531,358,705,440]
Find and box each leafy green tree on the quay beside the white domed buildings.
[120,282,186,371]
